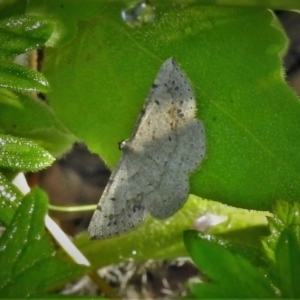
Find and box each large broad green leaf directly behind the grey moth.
[43,3,300,209]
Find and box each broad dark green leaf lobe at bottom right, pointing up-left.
[184,231,276,299]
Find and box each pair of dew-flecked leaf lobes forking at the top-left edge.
[0,16,53,92]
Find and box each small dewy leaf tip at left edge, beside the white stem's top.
[0,173,22,226]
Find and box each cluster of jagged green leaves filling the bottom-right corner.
[184,201,300,299]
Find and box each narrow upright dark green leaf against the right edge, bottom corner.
[274,229,300,299]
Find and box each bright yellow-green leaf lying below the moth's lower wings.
[62,195,266,268]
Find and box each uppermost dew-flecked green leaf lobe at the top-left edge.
[0,15,54,60]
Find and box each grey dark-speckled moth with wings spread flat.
[88,58,205,239]
